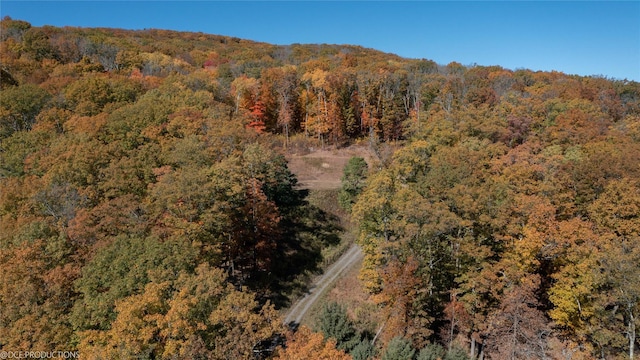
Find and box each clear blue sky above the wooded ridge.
[0,0,640,81]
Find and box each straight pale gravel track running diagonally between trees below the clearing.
[284,244,364,324]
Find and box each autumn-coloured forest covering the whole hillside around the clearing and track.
[0,17,640,360]
